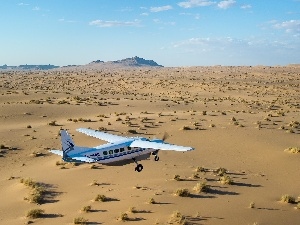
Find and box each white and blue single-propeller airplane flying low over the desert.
[50,128,194,172]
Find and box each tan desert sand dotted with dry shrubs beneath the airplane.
[0,66,300,225]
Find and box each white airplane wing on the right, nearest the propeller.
[130,140,194,151]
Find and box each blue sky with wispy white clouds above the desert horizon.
[0,0,300,66]
